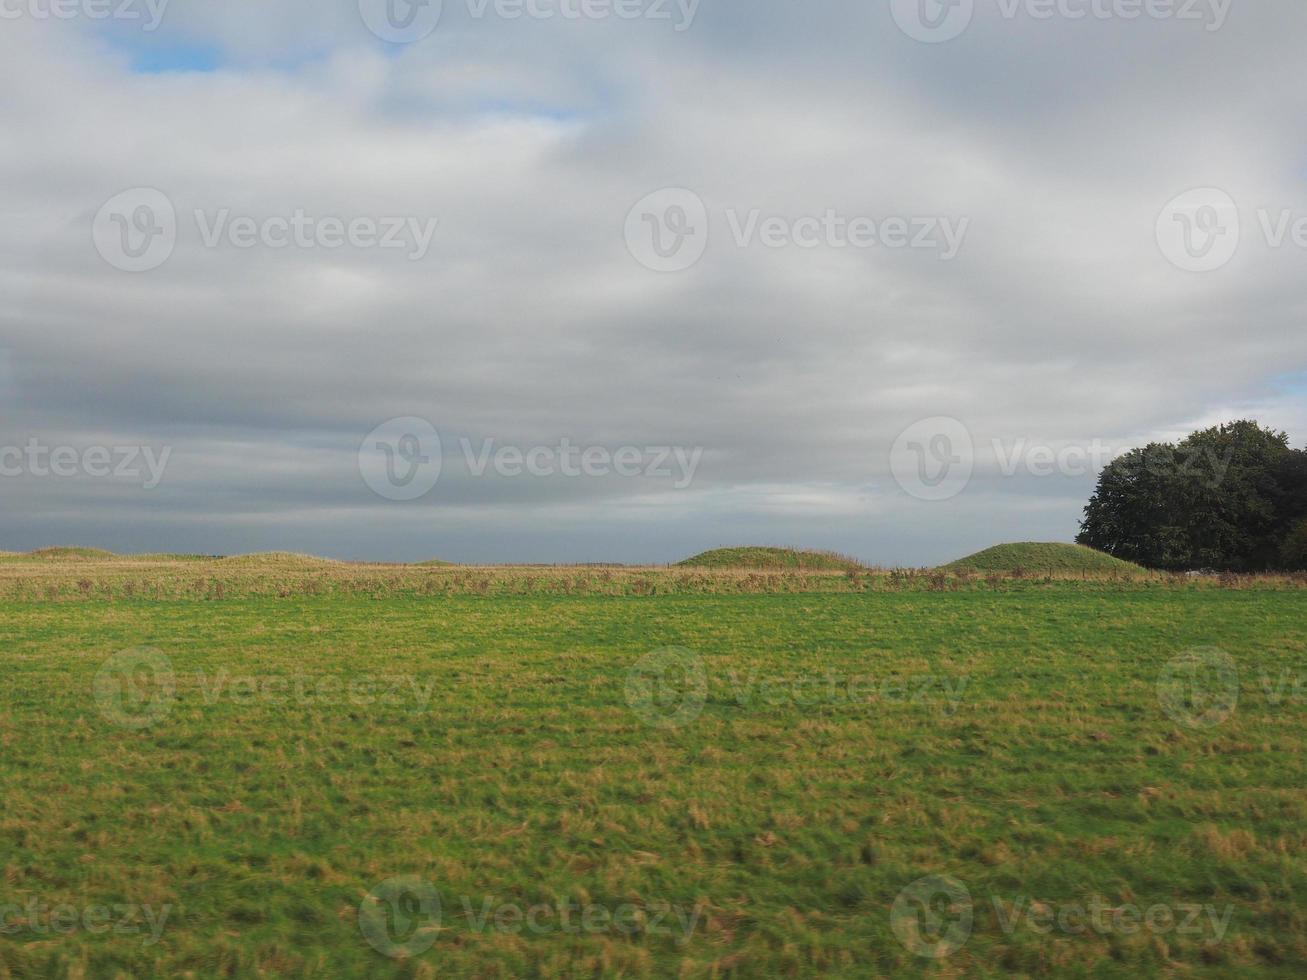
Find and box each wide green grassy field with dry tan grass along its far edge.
[0,555,1307,977]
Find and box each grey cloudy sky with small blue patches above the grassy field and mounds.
[0,0,1307,564]
